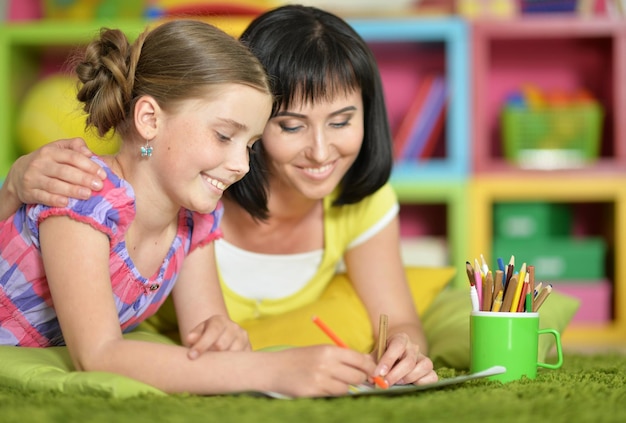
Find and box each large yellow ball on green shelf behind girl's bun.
[16,74,119,154]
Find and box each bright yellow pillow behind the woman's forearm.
[240,267,456,352]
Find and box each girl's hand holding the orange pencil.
[270,345,376,397]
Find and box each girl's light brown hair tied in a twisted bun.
[74,20,271,137]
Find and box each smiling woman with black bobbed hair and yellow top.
[5,5,437,384]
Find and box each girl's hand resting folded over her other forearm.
[184,315,252,360]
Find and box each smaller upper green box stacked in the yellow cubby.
[493,202,572,240]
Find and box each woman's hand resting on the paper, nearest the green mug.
[376,333,438,386]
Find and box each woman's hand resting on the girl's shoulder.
[7,138,106,207]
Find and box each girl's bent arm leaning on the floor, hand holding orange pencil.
[40,217,375,396]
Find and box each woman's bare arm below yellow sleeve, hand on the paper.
[345,216,437,384]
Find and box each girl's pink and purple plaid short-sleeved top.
[0,157,223,347]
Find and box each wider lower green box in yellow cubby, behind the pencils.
[493,237,606,283]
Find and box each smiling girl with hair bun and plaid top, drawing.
[0,20,375,396]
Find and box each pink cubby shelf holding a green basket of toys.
[471,17,626,175]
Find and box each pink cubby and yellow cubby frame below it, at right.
[469,16,626,344]
